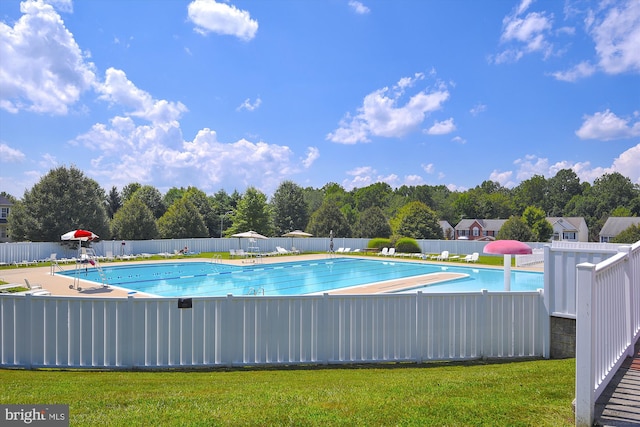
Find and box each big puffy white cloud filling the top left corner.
[0,0,95,115]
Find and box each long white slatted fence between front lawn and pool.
[0,290,548,369]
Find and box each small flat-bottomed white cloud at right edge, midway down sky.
[576,110,640,141]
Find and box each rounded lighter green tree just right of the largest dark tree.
[111,197,159,240]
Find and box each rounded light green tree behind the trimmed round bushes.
[393,202,444,239]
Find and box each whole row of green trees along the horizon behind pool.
[5,166,640,242]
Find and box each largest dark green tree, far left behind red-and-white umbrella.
[8,166,109,242]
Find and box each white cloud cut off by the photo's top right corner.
[587,0,640,74]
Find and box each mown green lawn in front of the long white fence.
[0,359,575,426]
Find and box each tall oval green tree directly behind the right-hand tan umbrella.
[271,181,309,236]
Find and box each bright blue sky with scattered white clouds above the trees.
[0,0,640,198]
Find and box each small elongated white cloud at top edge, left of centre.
[187,0,258,41]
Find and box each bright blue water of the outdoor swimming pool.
[61,258,544,297]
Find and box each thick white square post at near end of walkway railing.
[575,262,596,427]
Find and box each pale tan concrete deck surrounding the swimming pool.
[0,254,543,298]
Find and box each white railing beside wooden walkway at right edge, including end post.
[575,242,640,426]
